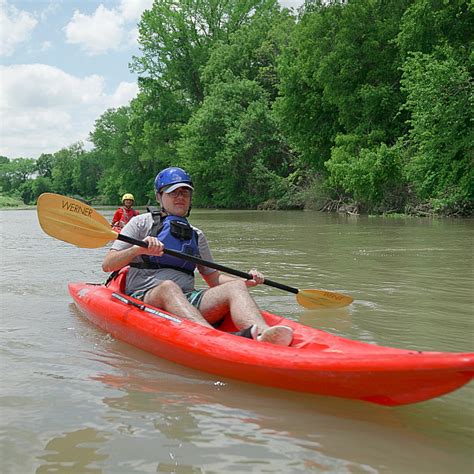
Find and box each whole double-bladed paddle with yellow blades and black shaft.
[37,193,353,309]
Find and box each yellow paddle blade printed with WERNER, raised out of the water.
[36,193,118,249]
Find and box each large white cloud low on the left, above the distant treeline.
[0,64,138,158]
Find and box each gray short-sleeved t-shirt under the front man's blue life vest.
[111,212,216,295]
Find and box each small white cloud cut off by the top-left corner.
[0,0,38,56]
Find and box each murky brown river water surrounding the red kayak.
[0,210,474,474]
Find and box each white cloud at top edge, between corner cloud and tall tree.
[64,0,153,55]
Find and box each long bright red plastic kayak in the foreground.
[69,270,474,406]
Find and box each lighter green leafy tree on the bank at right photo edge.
[402,48,474,212]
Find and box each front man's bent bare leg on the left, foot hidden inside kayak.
[143,280,212,327]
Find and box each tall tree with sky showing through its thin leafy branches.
[125,0,286,204]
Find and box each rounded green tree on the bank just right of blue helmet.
[179,79,288,208]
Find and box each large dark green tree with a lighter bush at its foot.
[275,0,411,209]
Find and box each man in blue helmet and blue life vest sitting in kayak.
[102,168,293,346]
